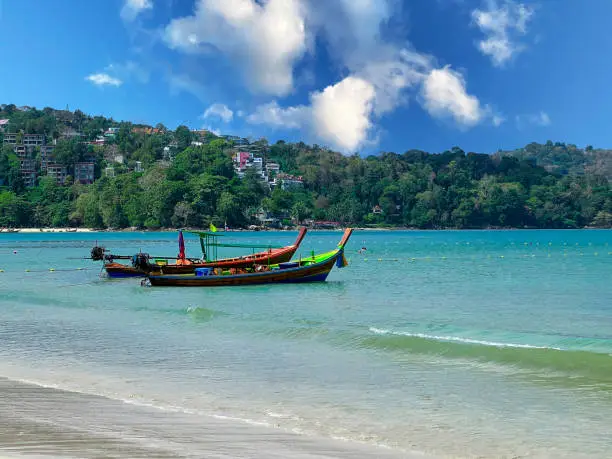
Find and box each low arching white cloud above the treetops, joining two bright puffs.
[246,63,490,153]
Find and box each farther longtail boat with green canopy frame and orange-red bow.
[91,227,307,277]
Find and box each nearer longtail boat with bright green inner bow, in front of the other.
[143,228,353,287]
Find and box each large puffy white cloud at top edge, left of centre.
[165,0,307,95]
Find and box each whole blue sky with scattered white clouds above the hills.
[0,0,612,153]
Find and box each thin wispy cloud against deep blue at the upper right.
[472,0,534,67]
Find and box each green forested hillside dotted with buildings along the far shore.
[0,105,612,229]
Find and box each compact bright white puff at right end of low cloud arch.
[421,66,486,127]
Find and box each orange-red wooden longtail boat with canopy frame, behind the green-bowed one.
[104,227,307,277]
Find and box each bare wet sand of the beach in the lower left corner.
[0,378,429,459]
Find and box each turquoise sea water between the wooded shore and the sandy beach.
[0,231,612,458]
